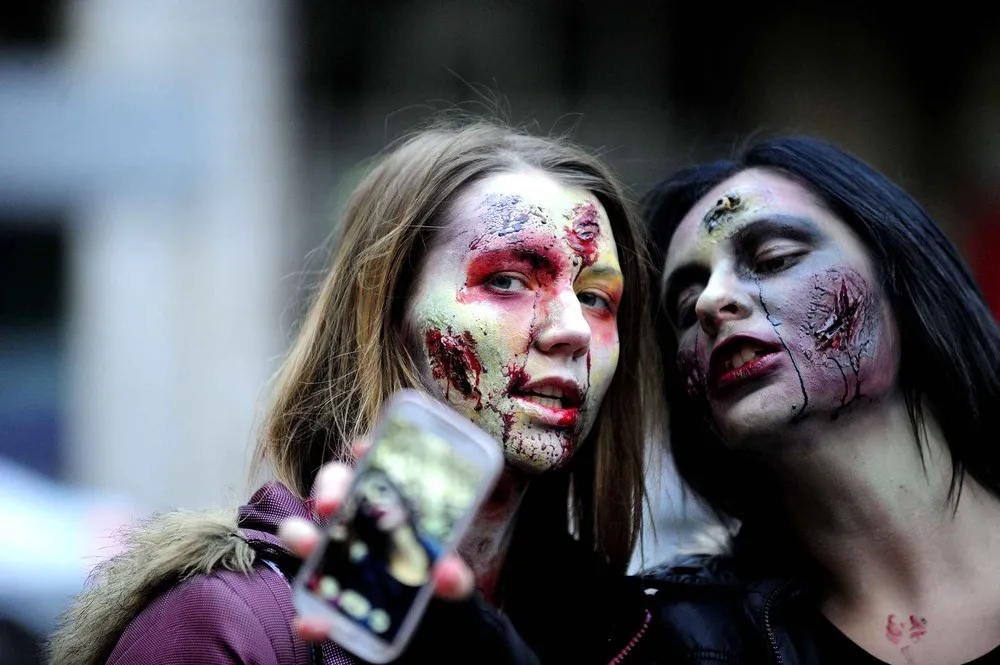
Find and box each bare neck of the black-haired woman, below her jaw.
[774,399,1000,607]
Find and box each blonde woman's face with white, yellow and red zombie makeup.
[407,171,623,472]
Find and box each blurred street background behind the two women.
[0,0,1000,665]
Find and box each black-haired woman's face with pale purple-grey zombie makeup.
[664,169,898,446]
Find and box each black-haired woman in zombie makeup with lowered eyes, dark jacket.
[645,137,1000,665]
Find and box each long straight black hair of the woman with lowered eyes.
[643,136,1000,536]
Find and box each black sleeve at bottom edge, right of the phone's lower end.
[395,596,541,665]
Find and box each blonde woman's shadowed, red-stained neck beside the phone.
[458,466,528,605]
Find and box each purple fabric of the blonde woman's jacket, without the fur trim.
[107,483,355,665]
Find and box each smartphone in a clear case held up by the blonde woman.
[293,389,503,663]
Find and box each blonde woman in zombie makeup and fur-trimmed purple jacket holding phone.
[52,122,658,665]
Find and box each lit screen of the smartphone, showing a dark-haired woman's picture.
[305,418,486,642]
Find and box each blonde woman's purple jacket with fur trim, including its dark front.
[49,483,632,665]
